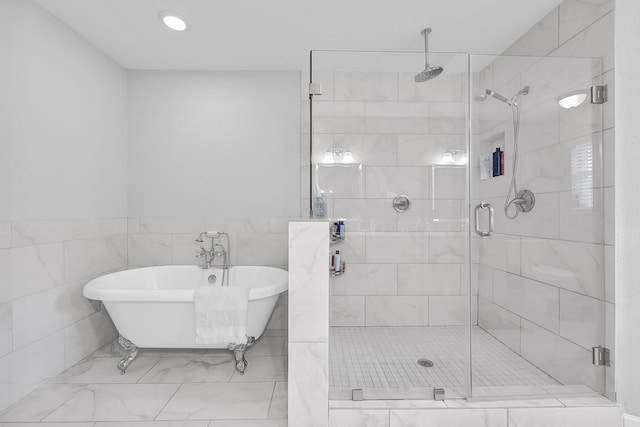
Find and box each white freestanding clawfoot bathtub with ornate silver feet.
[83,265,288,374]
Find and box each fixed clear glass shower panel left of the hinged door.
[310,51,468,400]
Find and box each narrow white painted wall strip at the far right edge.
[615,0,640,418]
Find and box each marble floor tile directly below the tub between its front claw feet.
[138,355,235,384]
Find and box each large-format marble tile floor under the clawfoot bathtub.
[0,331,287,427]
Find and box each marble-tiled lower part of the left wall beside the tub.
[0,218,127,408]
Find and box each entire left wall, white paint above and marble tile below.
[0,0,127,409]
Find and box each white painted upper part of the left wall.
[0,1,127,219]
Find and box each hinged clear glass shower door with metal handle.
[469,55,613,397]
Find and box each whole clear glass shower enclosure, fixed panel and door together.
[302,51,607,400]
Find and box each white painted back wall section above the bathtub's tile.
[129,71,300,218]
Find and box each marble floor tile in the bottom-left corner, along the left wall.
[0,384,86,421]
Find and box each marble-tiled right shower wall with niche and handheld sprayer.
[472,0,615,398]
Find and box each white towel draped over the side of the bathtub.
[193,286,249,346]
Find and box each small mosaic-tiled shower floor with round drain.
[329,326,560,399]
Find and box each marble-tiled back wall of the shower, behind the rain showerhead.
[301,70,466,326]
